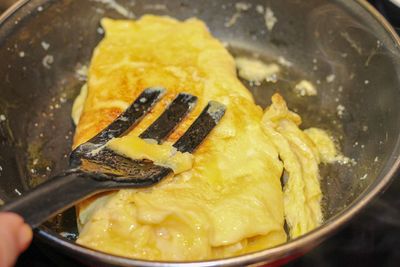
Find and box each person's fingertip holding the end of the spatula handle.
[0,212,32,267]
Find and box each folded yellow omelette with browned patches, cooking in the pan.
[73,15,336,261]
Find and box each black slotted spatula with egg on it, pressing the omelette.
[0,88,225,228]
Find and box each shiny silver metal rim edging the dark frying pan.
[0,0,400,267]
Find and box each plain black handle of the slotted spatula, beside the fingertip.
[0,173,98,228]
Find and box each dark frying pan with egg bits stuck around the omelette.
[0,0,400,266]
